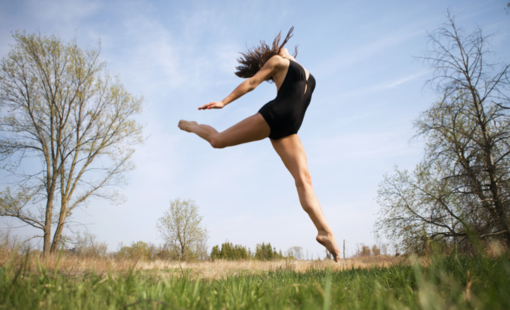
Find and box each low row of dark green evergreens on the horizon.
[210,242,295,260]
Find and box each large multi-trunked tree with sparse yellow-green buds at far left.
[0,32,143,255]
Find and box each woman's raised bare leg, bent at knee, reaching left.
[179,113,271,148]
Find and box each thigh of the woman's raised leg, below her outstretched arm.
[216,113,271,147]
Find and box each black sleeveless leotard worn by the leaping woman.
[259,59,315,140]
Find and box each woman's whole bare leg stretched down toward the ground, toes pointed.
[271,134,340,262]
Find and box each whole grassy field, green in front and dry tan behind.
[0,254,510,309]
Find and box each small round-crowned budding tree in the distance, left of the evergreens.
[156,198,207,260]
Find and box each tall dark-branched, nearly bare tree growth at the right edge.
[376,12,510,251]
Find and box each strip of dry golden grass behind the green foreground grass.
[0,248,403,279]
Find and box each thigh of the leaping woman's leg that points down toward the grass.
[271,134,309,181]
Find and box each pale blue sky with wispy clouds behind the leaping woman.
[0,0,510,256]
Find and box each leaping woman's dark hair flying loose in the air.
[235,27,297,81]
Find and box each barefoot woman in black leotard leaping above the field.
[179,27,340,262]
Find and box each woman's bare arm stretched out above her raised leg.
[198,56,283,110]
